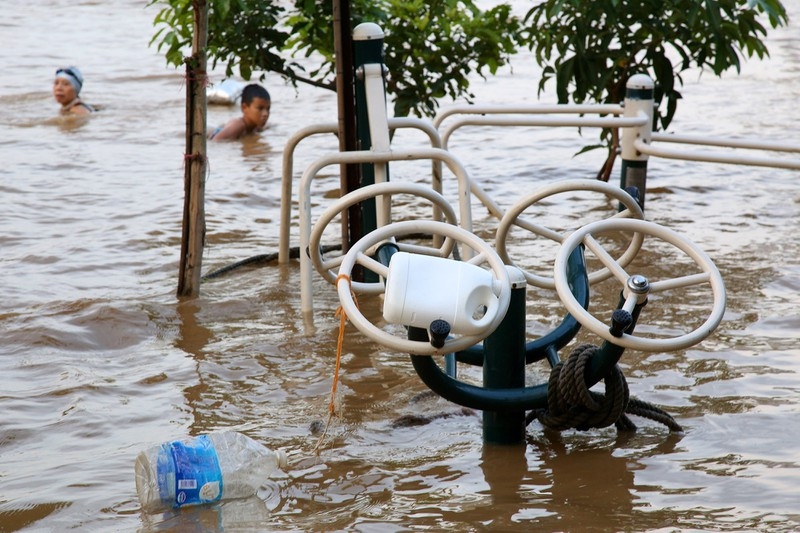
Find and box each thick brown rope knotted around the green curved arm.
[527,344,683,432]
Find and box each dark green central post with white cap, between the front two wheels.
[483,266,526,444]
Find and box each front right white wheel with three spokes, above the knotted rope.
[554,219,726,352]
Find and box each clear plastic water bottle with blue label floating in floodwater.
[135,431,287,510]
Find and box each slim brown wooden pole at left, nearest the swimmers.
[178,0,208,296]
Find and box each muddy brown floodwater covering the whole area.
[0,0,800,532]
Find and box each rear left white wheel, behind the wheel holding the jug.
[308,181,458,294]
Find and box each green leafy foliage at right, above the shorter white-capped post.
[522,0,787,175]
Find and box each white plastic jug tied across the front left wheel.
[383,252,500,335]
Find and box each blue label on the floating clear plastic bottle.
[158,435,223,509]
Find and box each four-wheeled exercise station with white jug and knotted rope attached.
[311,175,725,443]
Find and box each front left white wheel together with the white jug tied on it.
[336,220,511,355]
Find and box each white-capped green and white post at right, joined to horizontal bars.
[620,74,654,209]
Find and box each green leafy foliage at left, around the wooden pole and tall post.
[145,0,520,116]
